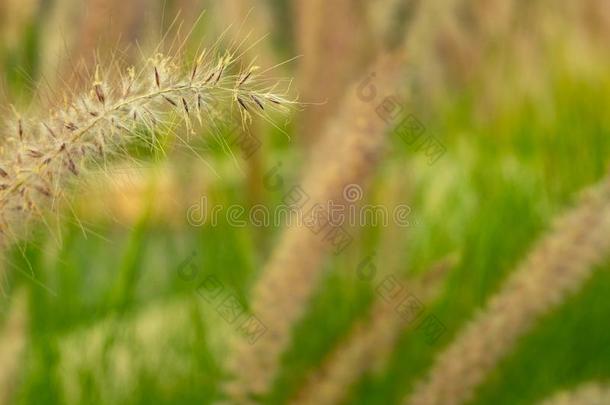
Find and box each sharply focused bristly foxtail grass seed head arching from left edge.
[0,37,296,243]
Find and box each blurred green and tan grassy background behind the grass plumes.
[0,0,610,404]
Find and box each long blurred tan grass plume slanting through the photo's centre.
[221,52,403,403]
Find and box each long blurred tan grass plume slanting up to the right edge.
[405,178,610,405]
